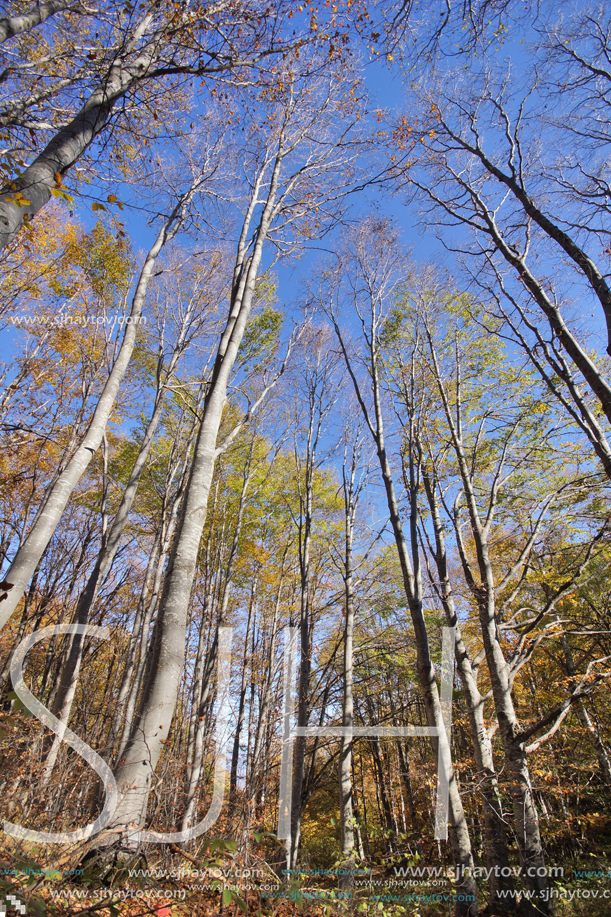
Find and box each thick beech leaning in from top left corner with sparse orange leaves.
[0,0,314,248]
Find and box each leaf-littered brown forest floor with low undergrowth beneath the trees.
[0,843,611,917]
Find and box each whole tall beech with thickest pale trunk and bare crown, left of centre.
[107,58,376,839]
